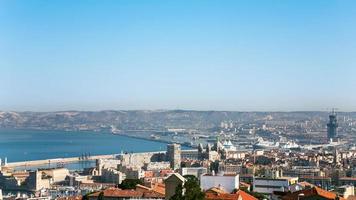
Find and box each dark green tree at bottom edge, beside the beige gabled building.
[170,175,204,200]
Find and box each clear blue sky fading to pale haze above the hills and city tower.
[0,0,356,111]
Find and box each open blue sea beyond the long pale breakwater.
[0,129,167,162]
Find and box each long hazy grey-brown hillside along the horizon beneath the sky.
[0,110,355,130]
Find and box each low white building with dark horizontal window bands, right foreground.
[253,177,298,194]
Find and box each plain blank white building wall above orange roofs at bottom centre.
[200,174,240,192]
